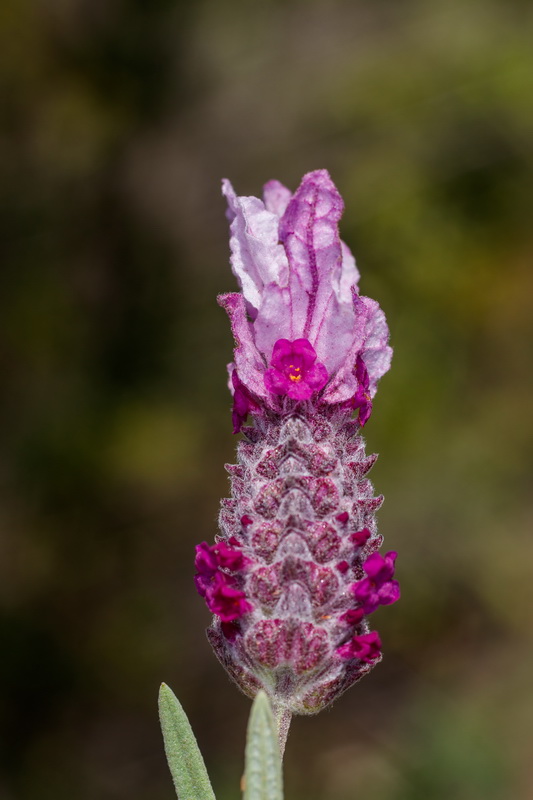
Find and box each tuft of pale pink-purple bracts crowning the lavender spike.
[219,170,392,430]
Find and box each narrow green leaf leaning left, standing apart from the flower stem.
[159,683,215,800]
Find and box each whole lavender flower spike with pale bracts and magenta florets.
[195,170,394,719]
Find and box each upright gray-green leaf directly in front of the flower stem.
[244,691,283,800]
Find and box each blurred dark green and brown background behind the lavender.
[0,0,533,800]
